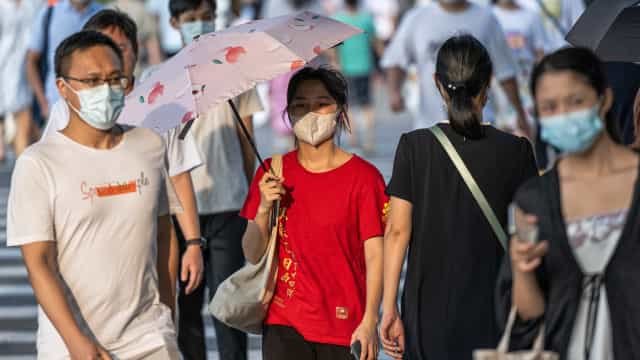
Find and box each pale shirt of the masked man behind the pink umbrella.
[190,89,262,214]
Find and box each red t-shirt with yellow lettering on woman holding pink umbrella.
[240,151,388,346]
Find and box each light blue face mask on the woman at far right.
[540,105,604,154]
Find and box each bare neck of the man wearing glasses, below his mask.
[61,109,122,150]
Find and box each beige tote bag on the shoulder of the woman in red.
[209,155,284,334]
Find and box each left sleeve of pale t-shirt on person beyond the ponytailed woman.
[380,10,417,69]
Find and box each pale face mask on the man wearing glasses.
[65,81,124,130]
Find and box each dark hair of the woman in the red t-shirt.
[284,66,350,132]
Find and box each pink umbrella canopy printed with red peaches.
[118,11,361,133]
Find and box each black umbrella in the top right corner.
[566,0,640,62]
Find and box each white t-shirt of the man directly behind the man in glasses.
[41,100,202,176]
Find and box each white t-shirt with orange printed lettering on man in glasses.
[7,128,180,360]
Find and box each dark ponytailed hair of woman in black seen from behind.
[436,35,493,139]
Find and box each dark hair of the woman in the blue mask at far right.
[530,47,622,143]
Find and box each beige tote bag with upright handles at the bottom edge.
[473,307,560,360]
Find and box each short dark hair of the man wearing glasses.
[54,30,123,77]
